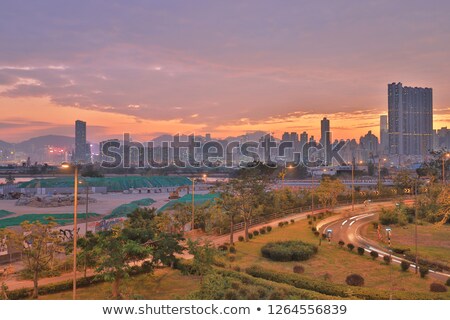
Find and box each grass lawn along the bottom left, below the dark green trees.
[39,268,200,300]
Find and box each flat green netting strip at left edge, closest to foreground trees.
[0,212,99,228]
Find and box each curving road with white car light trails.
[317,203,450,281]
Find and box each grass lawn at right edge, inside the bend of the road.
[362,224,450,265]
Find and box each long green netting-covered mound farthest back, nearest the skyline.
[19,176,191,192]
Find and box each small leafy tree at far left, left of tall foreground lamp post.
[20,219,64,299]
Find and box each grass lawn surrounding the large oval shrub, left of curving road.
[232,220,450,298]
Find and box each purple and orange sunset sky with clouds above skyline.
[0,0,450,142]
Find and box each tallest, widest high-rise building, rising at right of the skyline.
[388,82,433,155]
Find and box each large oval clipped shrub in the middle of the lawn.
[261,240,317,261]
